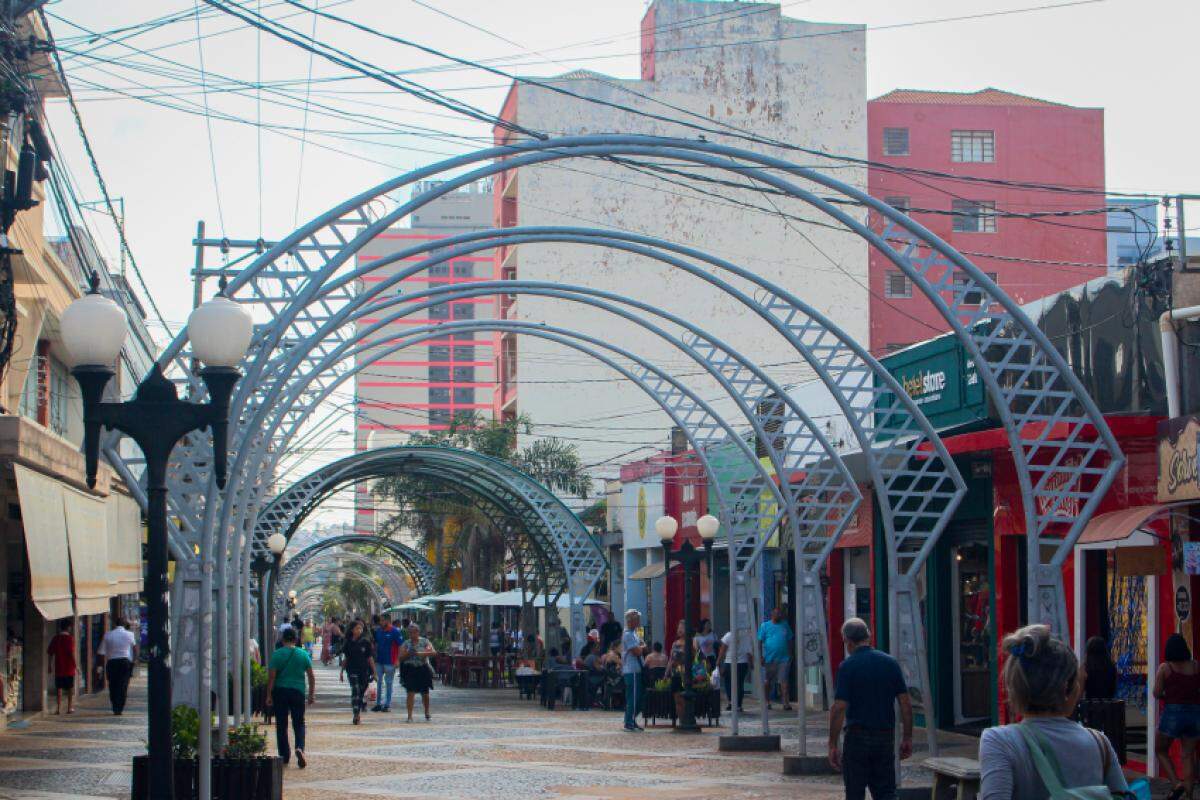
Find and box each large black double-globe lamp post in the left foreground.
[60,272,253,800]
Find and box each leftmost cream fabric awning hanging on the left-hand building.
[13,464,74,620]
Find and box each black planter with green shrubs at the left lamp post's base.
[132,705,283,800]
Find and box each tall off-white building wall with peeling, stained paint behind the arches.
[494,0,868,470]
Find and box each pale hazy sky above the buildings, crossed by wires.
[37,0,1200,520]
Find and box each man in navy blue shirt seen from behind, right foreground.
[829,616,912,800]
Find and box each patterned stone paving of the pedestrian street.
[0,663,974,800]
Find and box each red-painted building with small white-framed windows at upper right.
[868,89,1109,354]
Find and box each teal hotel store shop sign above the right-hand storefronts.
[882,336,988,429]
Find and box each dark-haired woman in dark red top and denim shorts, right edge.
[1154,633,1200,800]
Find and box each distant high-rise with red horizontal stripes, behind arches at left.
[354,181,499,534]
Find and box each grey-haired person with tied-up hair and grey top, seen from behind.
[979,625,1128,800]
